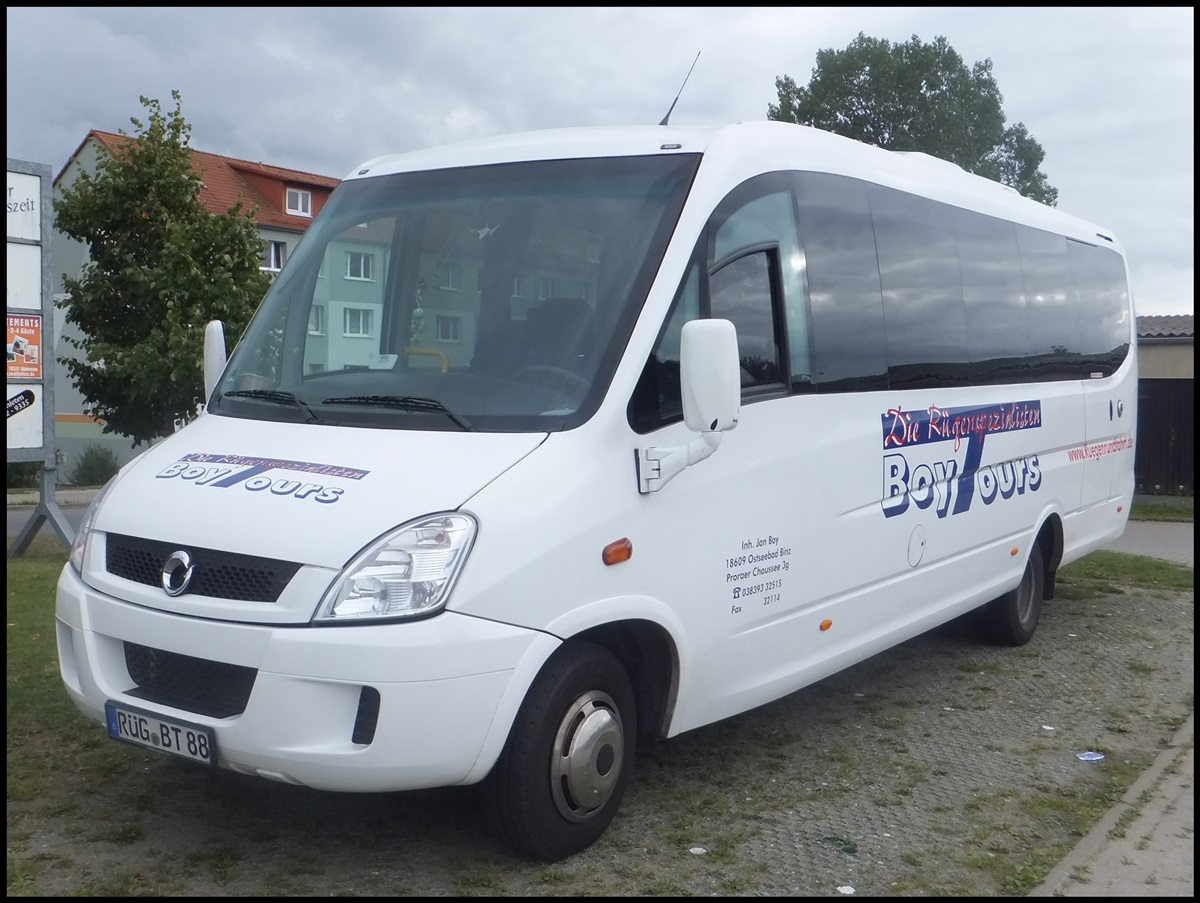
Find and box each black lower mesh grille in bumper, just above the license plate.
[125,642,258,718]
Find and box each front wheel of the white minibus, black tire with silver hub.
[484,642,637,862]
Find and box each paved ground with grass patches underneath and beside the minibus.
[8,581,1194,896]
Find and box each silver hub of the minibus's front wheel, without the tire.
[550,690,625,823]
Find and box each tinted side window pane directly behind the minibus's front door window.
[798,173,888,393]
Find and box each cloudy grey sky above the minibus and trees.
[7,6,1195,315]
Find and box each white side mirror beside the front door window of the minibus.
[679,319,742,432]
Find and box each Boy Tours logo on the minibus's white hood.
[157,452,370,504]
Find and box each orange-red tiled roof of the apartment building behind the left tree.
[55,128,340,232]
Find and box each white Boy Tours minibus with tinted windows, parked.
[56,121,1138,861]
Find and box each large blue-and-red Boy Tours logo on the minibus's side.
[881,401,1042,518]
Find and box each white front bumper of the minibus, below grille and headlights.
[55,566,558,793]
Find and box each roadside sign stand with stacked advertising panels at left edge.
[6,157,74,557]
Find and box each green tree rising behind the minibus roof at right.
[767,32,1058,207]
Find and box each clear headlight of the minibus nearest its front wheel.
[313,514,478,623]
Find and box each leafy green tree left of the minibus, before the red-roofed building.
[54,91,270,445]
